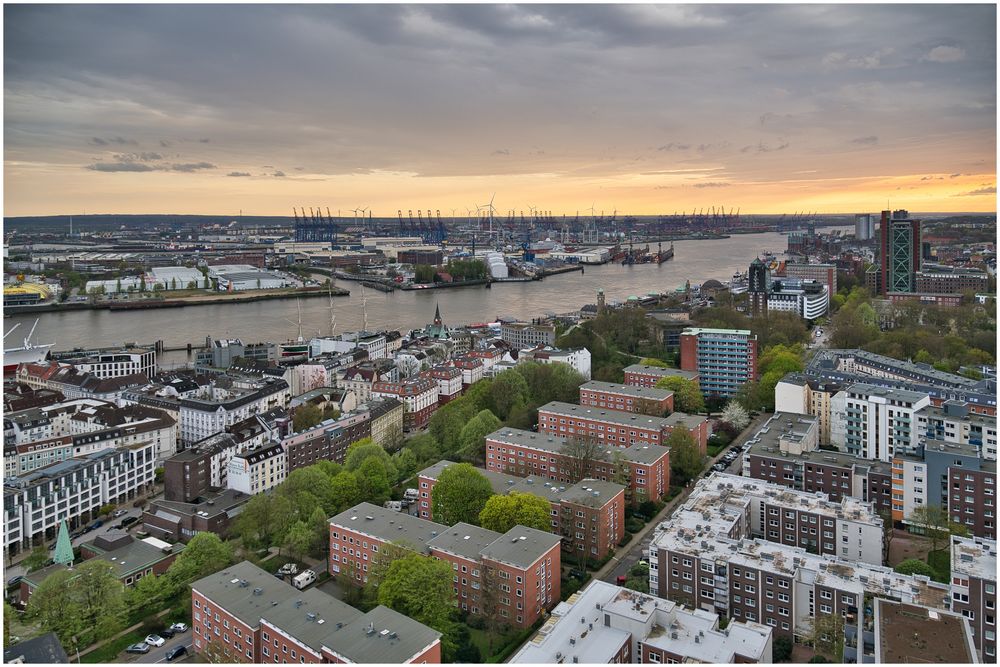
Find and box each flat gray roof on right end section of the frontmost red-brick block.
[326,606,441,665]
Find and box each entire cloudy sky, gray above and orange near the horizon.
[4,4,997,215]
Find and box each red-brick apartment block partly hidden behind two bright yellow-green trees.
[417,461,625,560]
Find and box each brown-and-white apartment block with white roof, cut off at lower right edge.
[951,536,997,663]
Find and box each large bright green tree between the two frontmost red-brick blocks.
[378,553,455,655]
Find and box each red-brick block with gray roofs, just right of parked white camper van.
[329,503,561,628]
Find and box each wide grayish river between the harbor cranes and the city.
[4,232,804,367]
